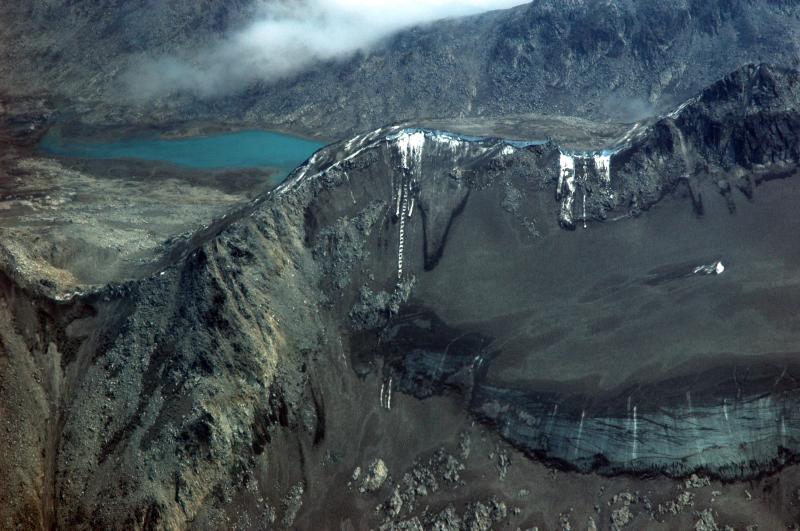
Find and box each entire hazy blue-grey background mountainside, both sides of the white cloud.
[0,0,800,138]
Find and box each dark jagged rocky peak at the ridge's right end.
[579,65,800,222]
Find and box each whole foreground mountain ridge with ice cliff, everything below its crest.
[0,66,800,529]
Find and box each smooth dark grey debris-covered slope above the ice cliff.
[417,177,800,402]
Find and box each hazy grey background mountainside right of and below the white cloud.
[234,0,800,135]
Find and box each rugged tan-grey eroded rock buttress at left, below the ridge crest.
[0,190,324,528]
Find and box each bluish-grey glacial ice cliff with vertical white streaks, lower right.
[473,386,800,479]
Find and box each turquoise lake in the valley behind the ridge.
[39,131,325,173]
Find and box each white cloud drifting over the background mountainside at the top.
[128,0,525,98]
